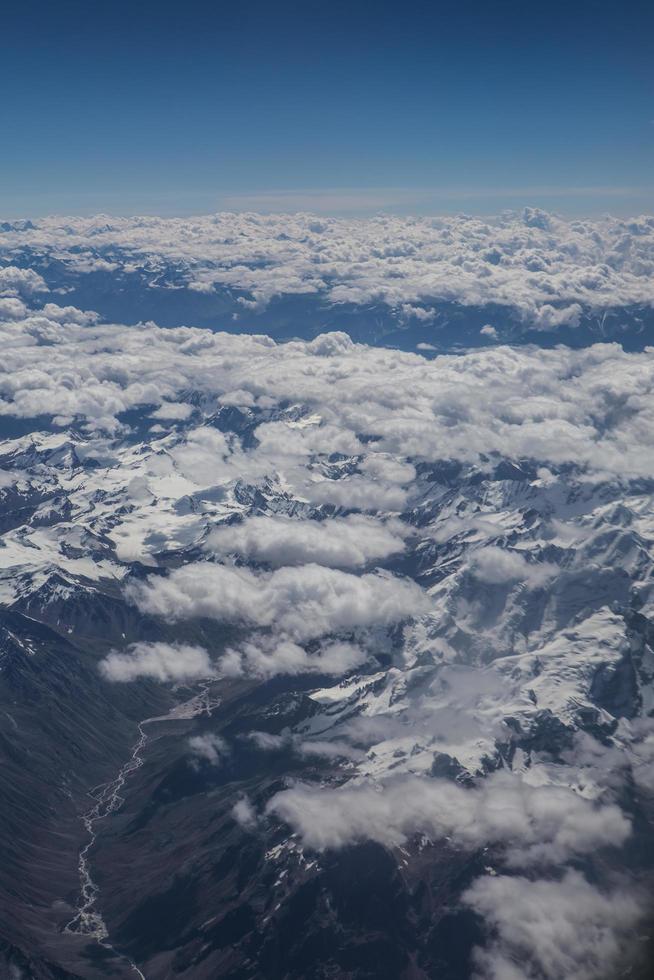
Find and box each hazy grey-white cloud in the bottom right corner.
[463,871,645,980]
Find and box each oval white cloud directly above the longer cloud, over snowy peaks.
[205,516,406,568]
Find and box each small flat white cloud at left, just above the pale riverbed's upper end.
[100,643,215,683]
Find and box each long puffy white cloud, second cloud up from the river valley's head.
[128,562,429,642]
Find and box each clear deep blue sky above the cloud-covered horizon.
[0,0,654,217]
